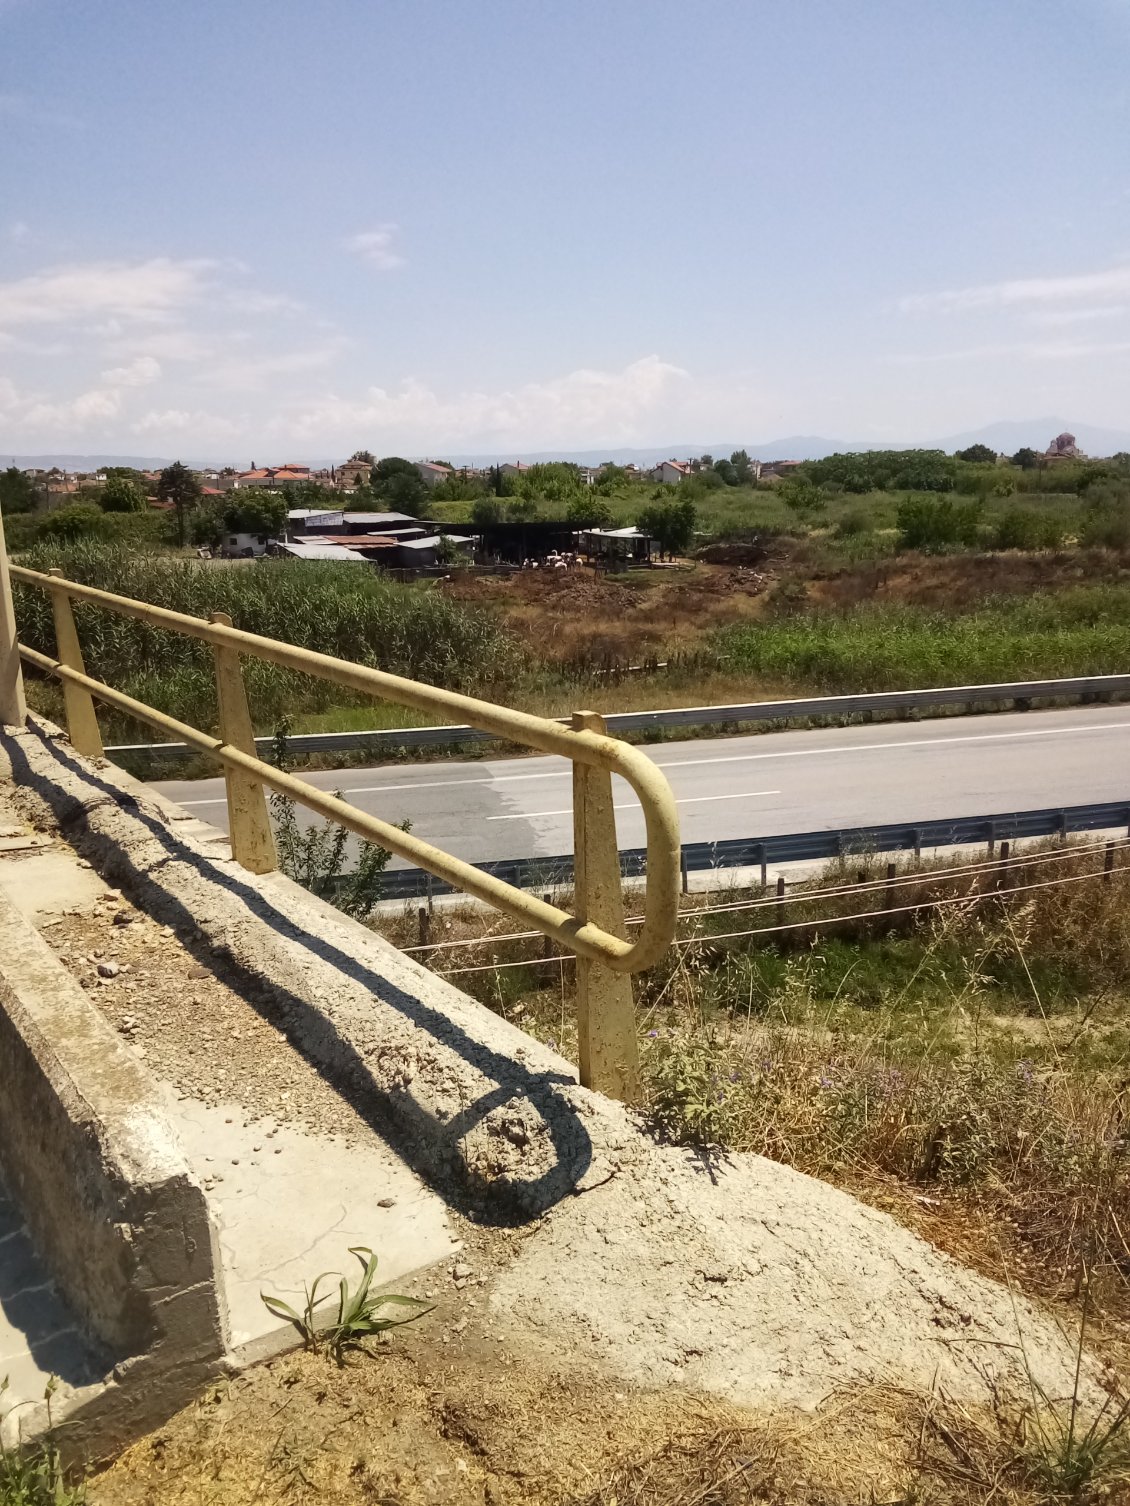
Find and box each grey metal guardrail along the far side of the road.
[107,675,1130,759]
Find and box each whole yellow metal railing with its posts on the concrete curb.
[0,560,680,1102]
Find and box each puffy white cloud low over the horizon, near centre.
[283,355,687,449]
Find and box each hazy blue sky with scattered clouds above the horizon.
[0,0,1130,464]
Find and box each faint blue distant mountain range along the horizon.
[8,417,1130,471]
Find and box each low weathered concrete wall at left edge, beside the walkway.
[0,896,226,1439]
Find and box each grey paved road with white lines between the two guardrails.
[155,706,1130,866]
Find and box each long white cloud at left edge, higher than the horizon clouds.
[0,256,217,327]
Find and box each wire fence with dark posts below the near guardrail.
[402,837,1130,977]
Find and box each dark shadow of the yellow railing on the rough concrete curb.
[0,720,594,1226]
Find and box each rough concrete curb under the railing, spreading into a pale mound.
[0,726,1098,1433]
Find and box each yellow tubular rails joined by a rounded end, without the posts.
[12,566,680,971]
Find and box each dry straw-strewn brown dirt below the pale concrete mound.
[90,1312,1000,1506]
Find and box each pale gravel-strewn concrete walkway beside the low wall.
[0,800,460,1411]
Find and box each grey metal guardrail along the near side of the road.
[376,801,1130,899]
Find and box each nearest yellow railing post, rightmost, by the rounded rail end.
[573,711,642,1104]
